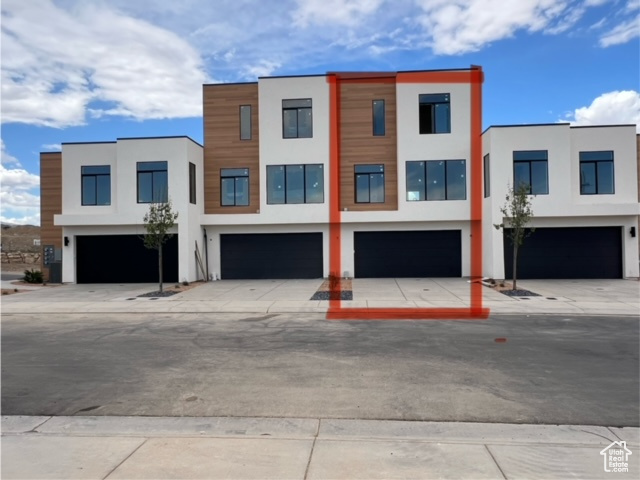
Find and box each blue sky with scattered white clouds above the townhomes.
[0,0,640,224]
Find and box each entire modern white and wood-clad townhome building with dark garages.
[41,71,640,283]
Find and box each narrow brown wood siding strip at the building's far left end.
[40,152,62,281]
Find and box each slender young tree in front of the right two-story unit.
[493,183,535,290]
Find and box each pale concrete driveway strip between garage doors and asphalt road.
[2,278,640,315]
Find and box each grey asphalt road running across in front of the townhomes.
[2,314,640,426]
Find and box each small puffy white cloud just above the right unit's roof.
[568,90,640,133]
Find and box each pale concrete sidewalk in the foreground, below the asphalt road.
[2,416,640,480]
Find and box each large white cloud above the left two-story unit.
[2,0,207,127]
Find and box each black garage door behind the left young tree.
[75,235,178,283]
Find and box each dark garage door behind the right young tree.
[504,227,622,278]
